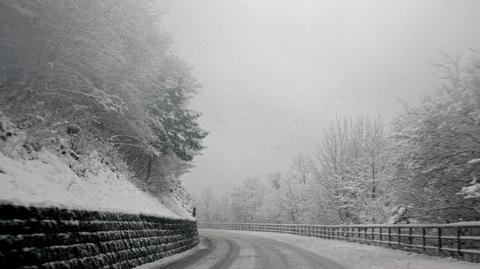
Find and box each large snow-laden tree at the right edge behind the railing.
[394,51,480,222]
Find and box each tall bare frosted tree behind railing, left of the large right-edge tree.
[316,118,389,223]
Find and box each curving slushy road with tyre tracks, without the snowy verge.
[157,230,345,269]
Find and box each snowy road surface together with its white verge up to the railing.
[137,229,479,269]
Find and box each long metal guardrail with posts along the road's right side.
[198,221,480,262]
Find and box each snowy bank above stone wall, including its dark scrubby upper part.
[0,111,197,219]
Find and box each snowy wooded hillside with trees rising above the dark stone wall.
[0,0,207,218]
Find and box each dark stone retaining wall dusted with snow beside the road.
[0,204,199,269]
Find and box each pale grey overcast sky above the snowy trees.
[163,0,480,194]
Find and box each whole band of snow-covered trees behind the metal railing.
[195,51,480,224]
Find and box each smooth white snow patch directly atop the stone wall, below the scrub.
[0,150,188,218]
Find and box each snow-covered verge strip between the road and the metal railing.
[229,228,480,269]
